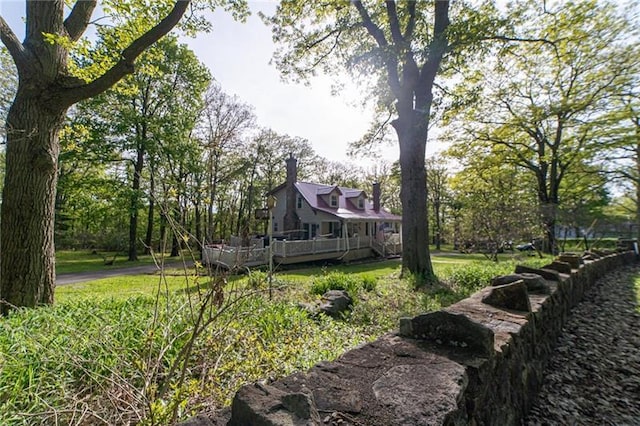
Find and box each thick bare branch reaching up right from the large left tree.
[62,0,191,105]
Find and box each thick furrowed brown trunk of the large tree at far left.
[0,99,66,314]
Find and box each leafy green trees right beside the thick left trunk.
[56,36,211,255]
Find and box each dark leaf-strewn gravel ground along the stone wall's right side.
[524,266,640,426]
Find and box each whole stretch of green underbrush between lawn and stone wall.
[0,255,542,425]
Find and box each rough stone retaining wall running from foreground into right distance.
[187,251,636,426]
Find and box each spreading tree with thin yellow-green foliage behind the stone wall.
[445,0,638,250]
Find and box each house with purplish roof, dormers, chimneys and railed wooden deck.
[203,156,402,268]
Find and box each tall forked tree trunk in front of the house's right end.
[351,1,449,283]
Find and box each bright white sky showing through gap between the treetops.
[0,0,398,165]
